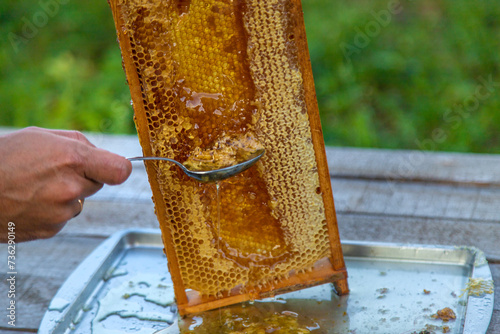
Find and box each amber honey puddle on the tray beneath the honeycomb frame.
[179,284,349,334]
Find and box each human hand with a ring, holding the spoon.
[0,127,132,242]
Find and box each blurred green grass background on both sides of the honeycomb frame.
[0,0,500,153]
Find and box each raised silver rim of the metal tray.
[38,228,494,334]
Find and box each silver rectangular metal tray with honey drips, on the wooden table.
[39,229,493,334]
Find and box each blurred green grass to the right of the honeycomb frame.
[303,0,500,153]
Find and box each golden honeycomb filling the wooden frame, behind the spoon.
[116,0,336,296]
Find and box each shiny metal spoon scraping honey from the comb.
[127,149,266,182]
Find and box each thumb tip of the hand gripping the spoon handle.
[80,148,132,185]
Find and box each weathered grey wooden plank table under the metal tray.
[0,129,500,334]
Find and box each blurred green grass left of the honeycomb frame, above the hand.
[0,0,135,133]
